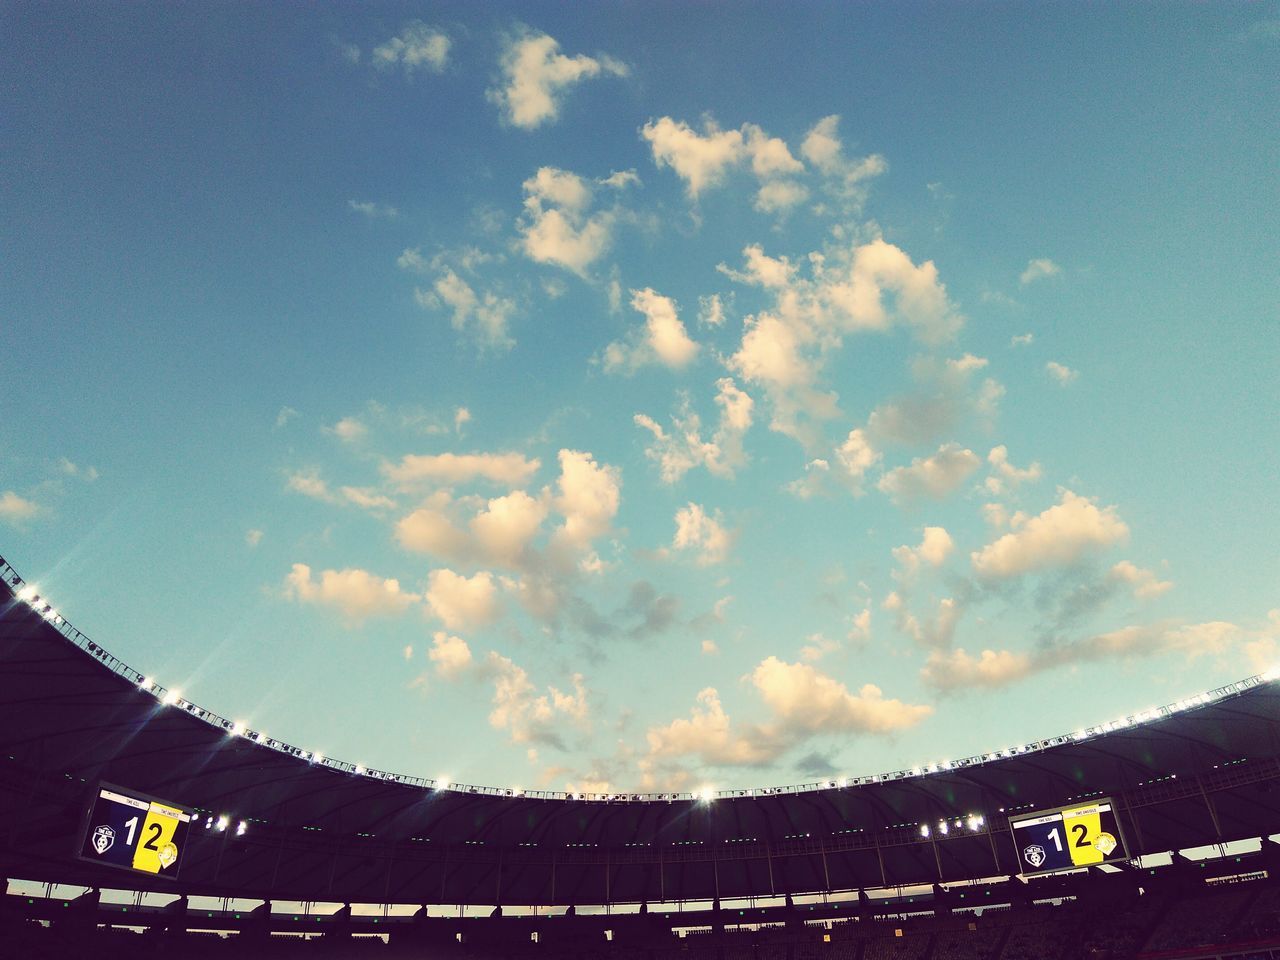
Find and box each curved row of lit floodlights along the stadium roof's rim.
[0,557,1280,804]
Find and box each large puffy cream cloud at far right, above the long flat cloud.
[970,490,1129,580]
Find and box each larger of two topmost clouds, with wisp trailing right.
[488,33,628,131]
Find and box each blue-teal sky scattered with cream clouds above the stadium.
[0,3,1280,792]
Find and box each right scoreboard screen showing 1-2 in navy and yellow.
[1009,800,1129,877]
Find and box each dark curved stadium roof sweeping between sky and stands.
[0,555,1280,904]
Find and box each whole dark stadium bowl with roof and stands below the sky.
[0,552,1280,960]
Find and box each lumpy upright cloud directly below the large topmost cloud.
[518,166,616,278]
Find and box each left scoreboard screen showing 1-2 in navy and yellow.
[79,783,191,877]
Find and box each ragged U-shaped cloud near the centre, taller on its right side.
[634,376,755,484]
